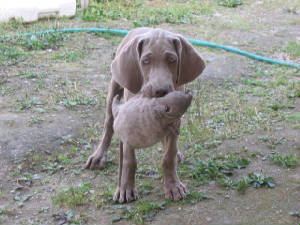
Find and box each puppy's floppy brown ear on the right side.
[173,35,205,85]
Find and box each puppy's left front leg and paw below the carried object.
[114,143,137,203]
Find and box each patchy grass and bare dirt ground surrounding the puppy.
[0,0,300,224]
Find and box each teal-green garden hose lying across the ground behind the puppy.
[10,27,300,69]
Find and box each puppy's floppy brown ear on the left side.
[111,36,143,94]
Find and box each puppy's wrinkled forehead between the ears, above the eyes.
[142,29,176,55]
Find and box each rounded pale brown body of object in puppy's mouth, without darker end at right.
[114,100,167,148]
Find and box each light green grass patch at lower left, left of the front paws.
[52,183,91,208]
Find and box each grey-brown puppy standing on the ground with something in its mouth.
[86,28,205,200]
